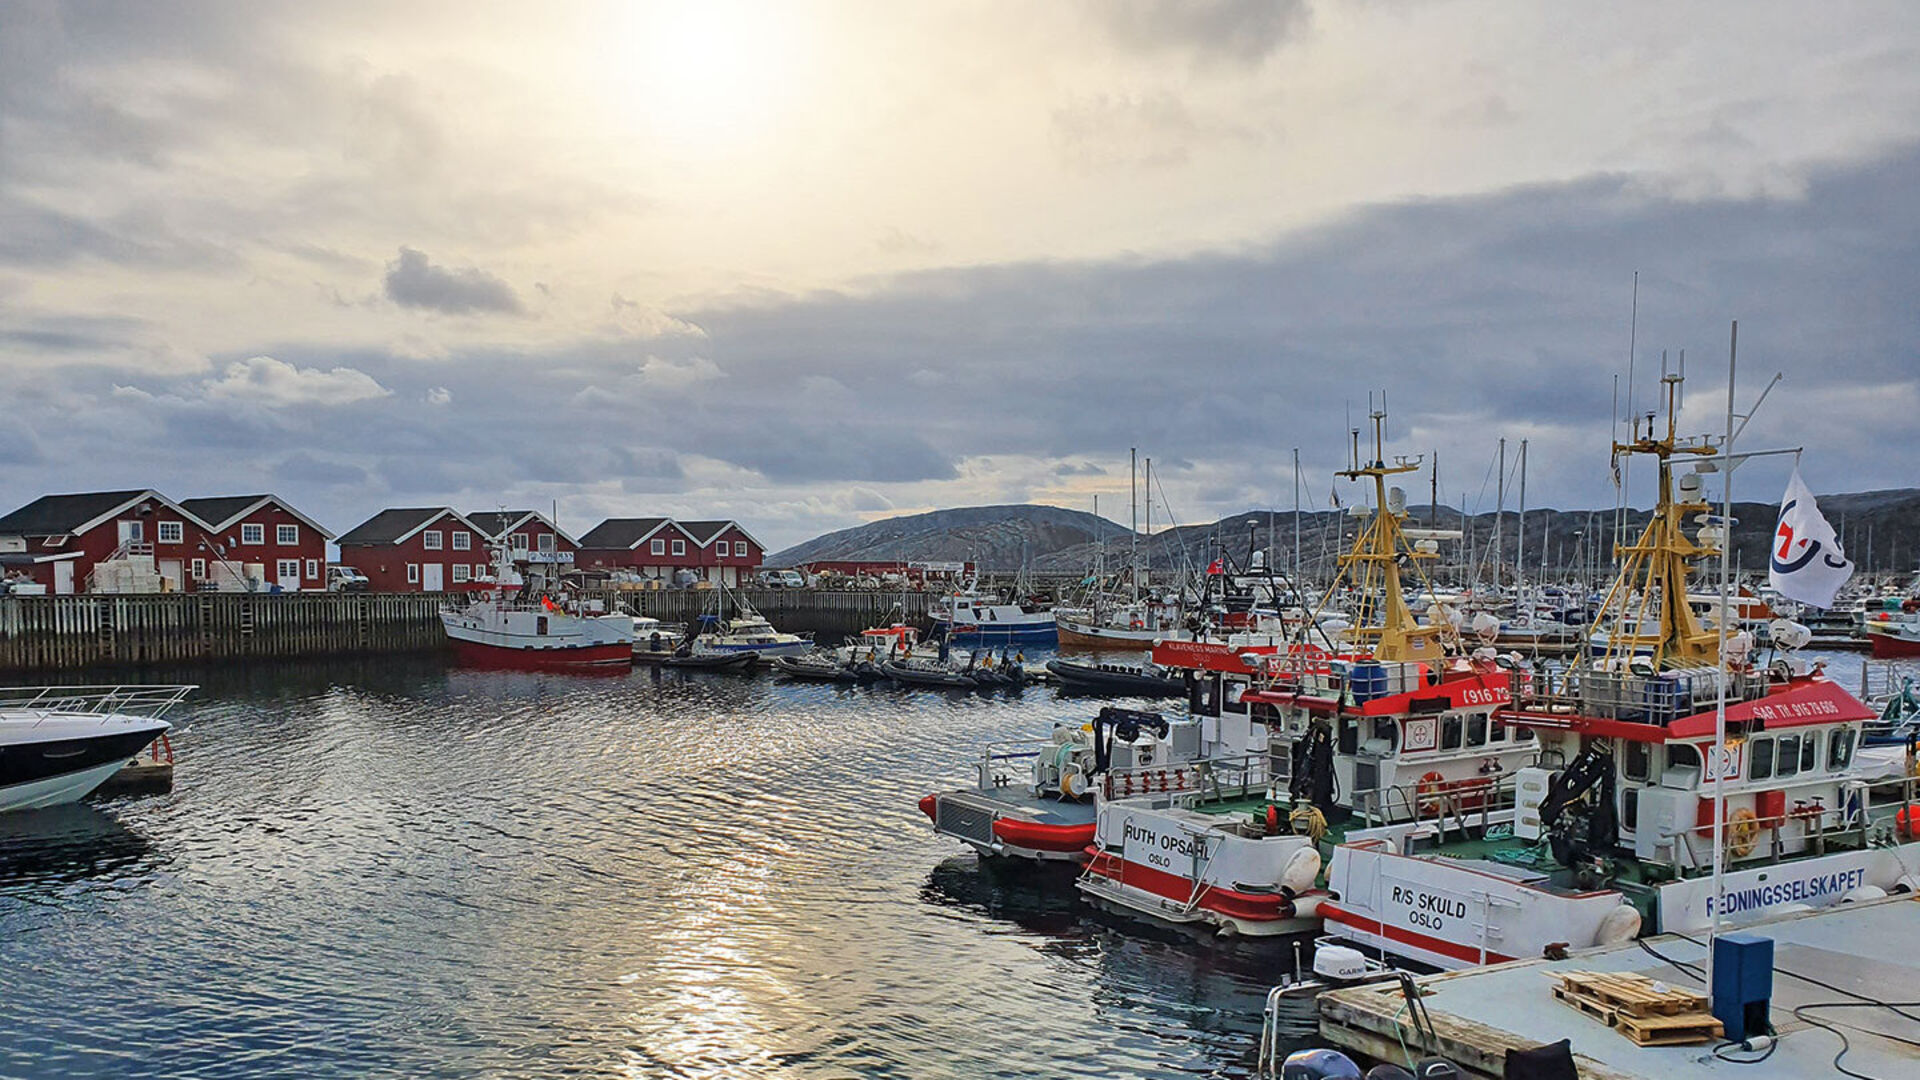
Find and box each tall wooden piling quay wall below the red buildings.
[0,588,929,671]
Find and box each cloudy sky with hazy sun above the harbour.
[0,0,1920,548]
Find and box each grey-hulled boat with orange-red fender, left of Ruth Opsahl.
[920,707,1204,863]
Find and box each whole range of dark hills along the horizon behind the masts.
[768,488,1920,578]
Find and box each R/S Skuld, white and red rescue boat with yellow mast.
[1321,375,1920,969]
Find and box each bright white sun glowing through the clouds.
[603,0,799,148]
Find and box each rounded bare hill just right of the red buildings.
[766,503,1127,571]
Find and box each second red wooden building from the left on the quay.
[180,496,334,592]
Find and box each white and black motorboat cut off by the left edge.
[0,686,194,813]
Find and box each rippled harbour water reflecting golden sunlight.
[0,661,1292,1078]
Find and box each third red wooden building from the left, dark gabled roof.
[336,505,493,592]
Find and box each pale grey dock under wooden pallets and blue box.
[1319,897,1920,1080]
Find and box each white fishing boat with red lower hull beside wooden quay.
[440,544,634,671]
